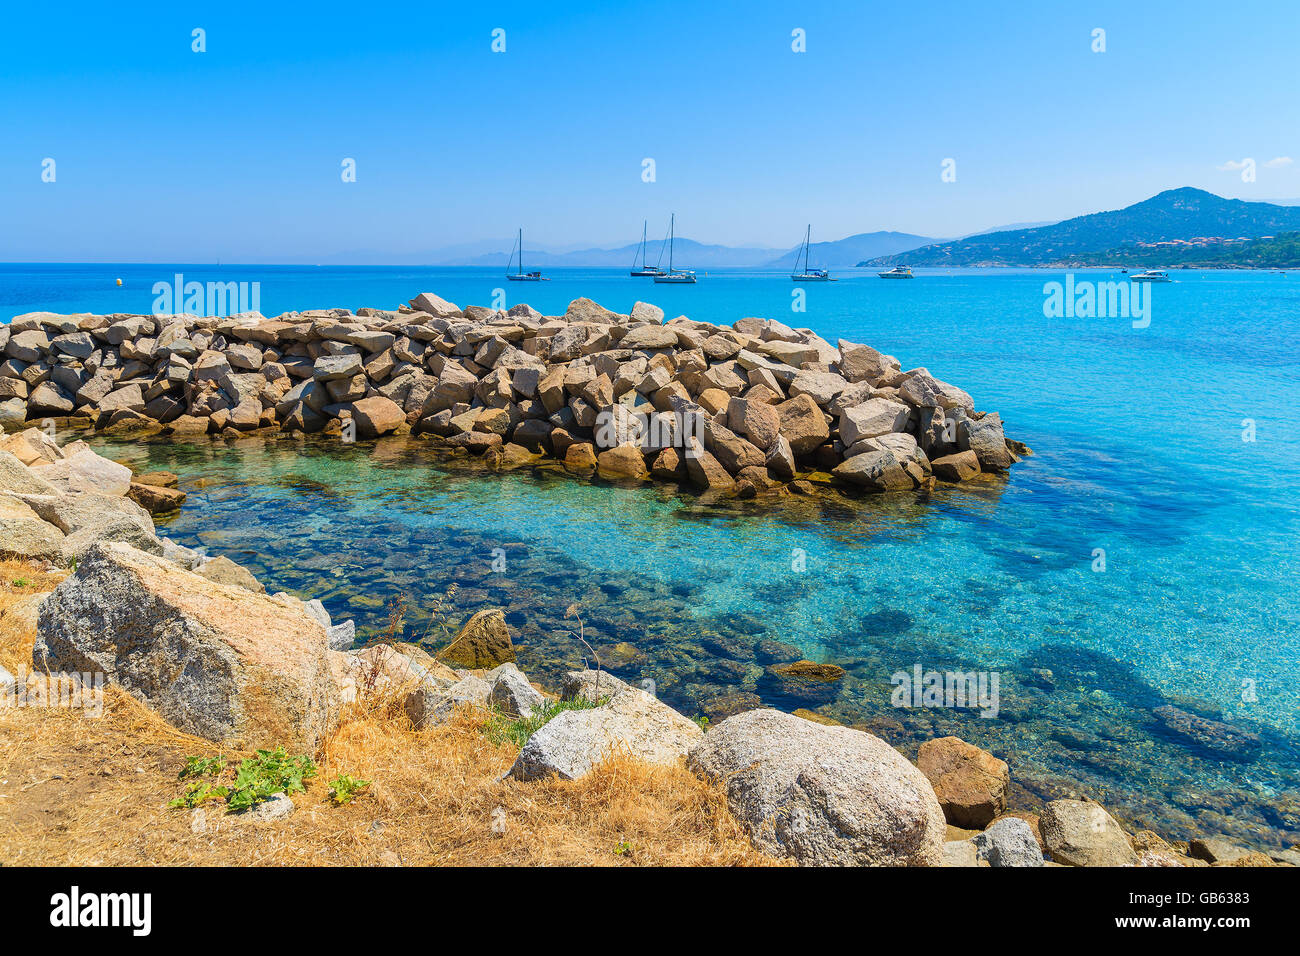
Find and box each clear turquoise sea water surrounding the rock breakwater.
[0,265,1300,845]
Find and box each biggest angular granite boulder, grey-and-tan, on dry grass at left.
[33,544,337,752]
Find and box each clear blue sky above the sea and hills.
[0,0,1300,263]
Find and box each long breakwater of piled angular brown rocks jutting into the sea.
[0,293,1028,497]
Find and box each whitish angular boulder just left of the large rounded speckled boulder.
[510,675,703,780]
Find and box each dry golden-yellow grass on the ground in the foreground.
[0,562,772,866]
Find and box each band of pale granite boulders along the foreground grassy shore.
[0,429,1284,866]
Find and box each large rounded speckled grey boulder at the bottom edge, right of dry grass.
[689,710,946,866]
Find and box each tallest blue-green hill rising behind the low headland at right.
[858,186,1300,267]
